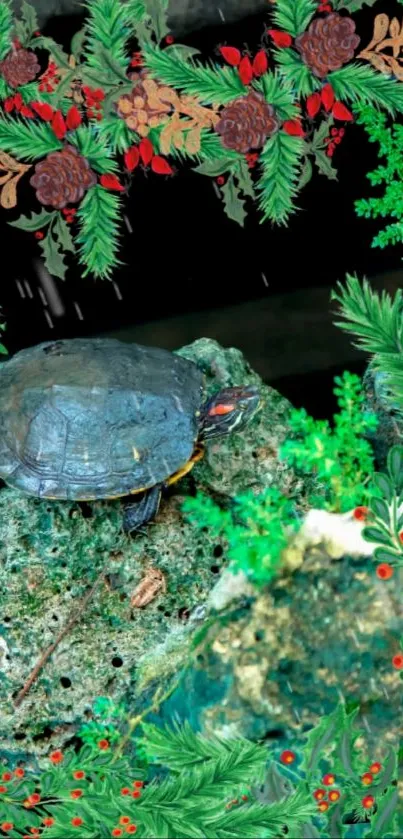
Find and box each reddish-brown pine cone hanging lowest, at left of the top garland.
[30,146,97,210]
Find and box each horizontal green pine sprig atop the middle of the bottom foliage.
[142,720,267,776]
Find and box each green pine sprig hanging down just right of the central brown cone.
[257,131,303,224]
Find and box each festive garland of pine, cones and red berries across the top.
[0,0,403,278]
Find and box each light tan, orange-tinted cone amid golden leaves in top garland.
[117,70,172,137]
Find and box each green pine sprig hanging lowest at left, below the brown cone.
[76,185,122,279]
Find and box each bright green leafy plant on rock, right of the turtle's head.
[280,371,377,513]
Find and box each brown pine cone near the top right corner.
[295,12,360,79]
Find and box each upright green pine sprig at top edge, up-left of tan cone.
[84,0,133,76]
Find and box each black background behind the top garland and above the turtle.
[0,2,403,416]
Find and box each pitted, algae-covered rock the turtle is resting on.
[0,339,298,754]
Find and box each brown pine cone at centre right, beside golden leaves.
[215,90,279,154]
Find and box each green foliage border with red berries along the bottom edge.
[0,703,398,839]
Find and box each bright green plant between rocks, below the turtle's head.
[183,487,300,586]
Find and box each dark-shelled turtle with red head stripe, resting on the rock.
[0,337,260,534]
